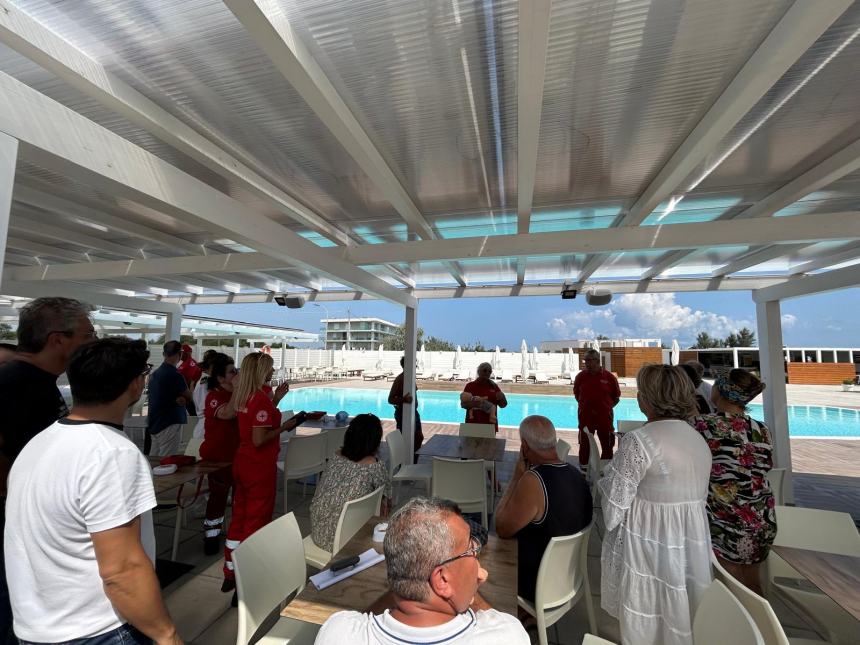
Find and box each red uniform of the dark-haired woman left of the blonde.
[200,387,239,537]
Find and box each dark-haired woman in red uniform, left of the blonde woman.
[200,353,239,555]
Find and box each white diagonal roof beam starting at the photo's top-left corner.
[0,0,352,244]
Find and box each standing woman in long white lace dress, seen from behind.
[598,365,711,645]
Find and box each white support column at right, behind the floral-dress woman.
[756,300,794,502]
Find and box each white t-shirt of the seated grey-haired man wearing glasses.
[314,609,529,645]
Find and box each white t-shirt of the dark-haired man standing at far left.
[5,419,156,643]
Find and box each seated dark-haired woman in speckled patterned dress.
[311,414,391,552]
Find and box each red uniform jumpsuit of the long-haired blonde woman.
[224,390,281,579]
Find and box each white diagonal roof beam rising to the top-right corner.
[579,0,851,280]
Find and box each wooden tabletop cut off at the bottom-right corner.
[771,546,860,620]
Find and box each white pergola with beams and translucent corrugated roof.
[0,0,860,495]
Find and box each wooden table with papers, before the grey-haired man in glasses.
[281,517,517,625]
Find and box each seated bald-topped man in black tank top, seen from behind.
[496,415,592,602]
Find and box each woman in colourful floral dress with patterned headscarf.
[692,369,776,595]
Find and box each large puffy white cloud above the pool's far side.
[547,293,752,345]
